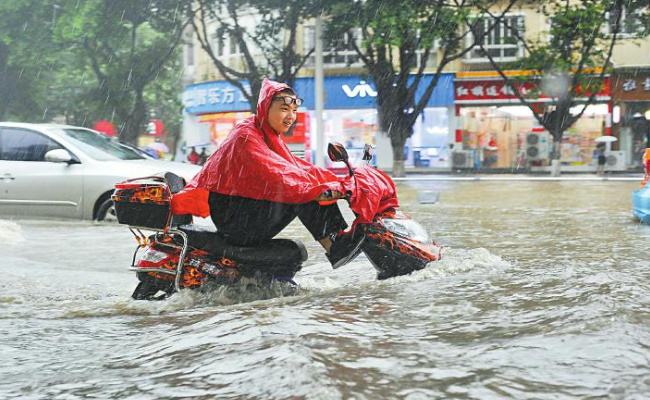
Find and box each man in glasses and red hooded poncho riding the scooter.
[172,79,364,268]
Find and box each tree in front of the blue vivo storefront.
[328,0,517,176]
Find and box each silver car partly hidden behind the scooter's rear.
[0,122,200,221]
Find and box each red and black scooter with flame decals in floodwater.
[112,143,440,300]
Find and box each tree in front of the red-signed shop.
[465,0,648,174]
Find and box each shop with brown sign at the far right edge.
[612,69,650,168]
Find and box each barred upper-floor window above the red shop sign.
[465,15,525,63]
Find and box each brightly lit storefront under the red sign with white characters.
[452,72,611,170]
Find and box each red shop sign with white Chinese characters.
[454,77,610,104]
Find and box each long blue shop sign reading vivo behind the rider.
[183,74,454,114]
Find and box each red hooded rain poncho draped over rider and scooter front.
[172,79,397,222]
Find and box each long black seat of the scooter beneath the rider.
[178,224,307,273]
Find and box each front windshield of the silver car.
[57,128,146,161]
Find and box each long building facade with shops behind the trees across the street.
[178,2,650,171]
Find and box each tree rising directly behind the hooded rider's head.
[192,0,321,112]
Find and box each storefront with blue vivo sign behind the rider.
[178,74,454,168]
